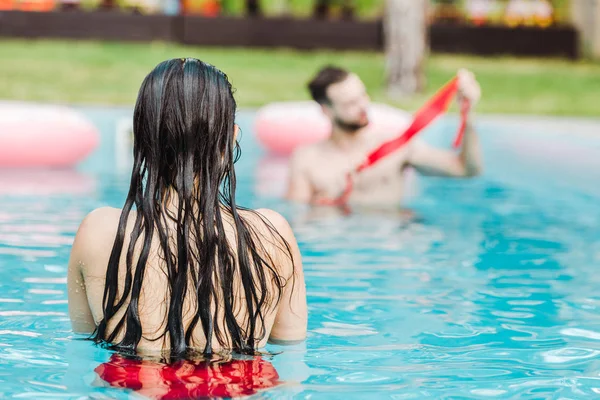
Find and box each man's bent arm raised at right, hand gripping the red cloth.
[408,70,482,177]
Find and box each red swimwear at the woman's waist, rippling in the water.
[94,354,281,400]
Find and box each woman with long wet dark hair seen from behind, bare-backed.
[68,58,307,357]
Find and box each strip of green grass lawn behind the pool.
[0,40,600,116]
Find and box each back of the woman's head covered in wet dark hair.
[133,58,237,190]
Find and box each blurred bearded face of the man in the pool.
[323,74,370,132]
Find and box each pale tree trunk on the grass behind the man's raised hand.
[383,0,427,98]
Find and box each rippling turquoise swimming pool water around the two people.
[0,109,600,399]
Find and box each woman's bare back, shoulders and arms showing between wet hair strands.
[68,208,307,352]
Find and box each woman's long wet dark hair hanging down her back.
[92,59,291,357]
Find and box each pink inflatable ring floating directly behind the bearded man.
[254,101,412,155]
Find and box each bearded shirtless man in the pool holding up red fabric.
[287,66,481,206]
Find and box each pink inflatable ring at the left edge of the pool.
[0,102,99,167]
